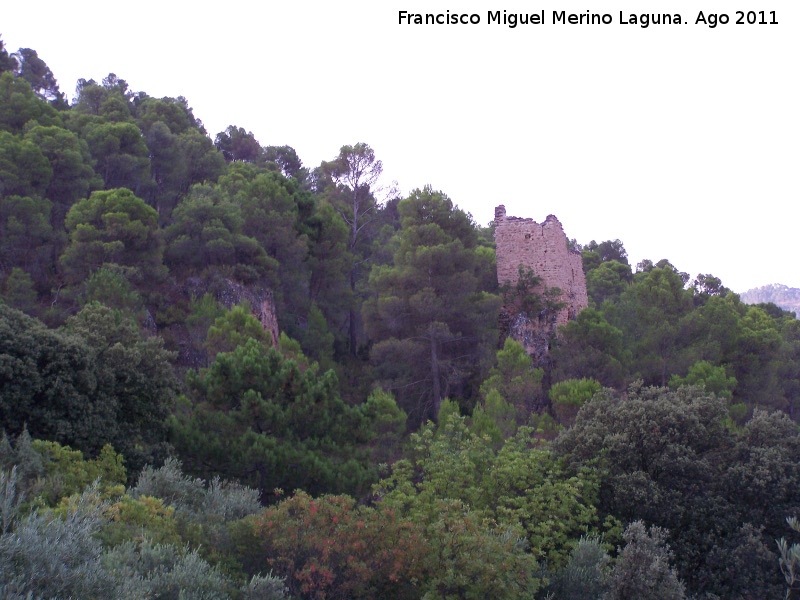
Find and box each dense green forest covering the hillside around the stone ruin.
[0,39,800,600]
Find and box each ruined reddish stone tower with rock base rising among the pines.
[494,204,589,365]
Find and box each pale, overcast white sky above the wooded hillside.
[0,0,800,292]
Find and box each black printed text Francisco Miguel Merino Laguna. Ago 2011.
[399,10,778,29]
